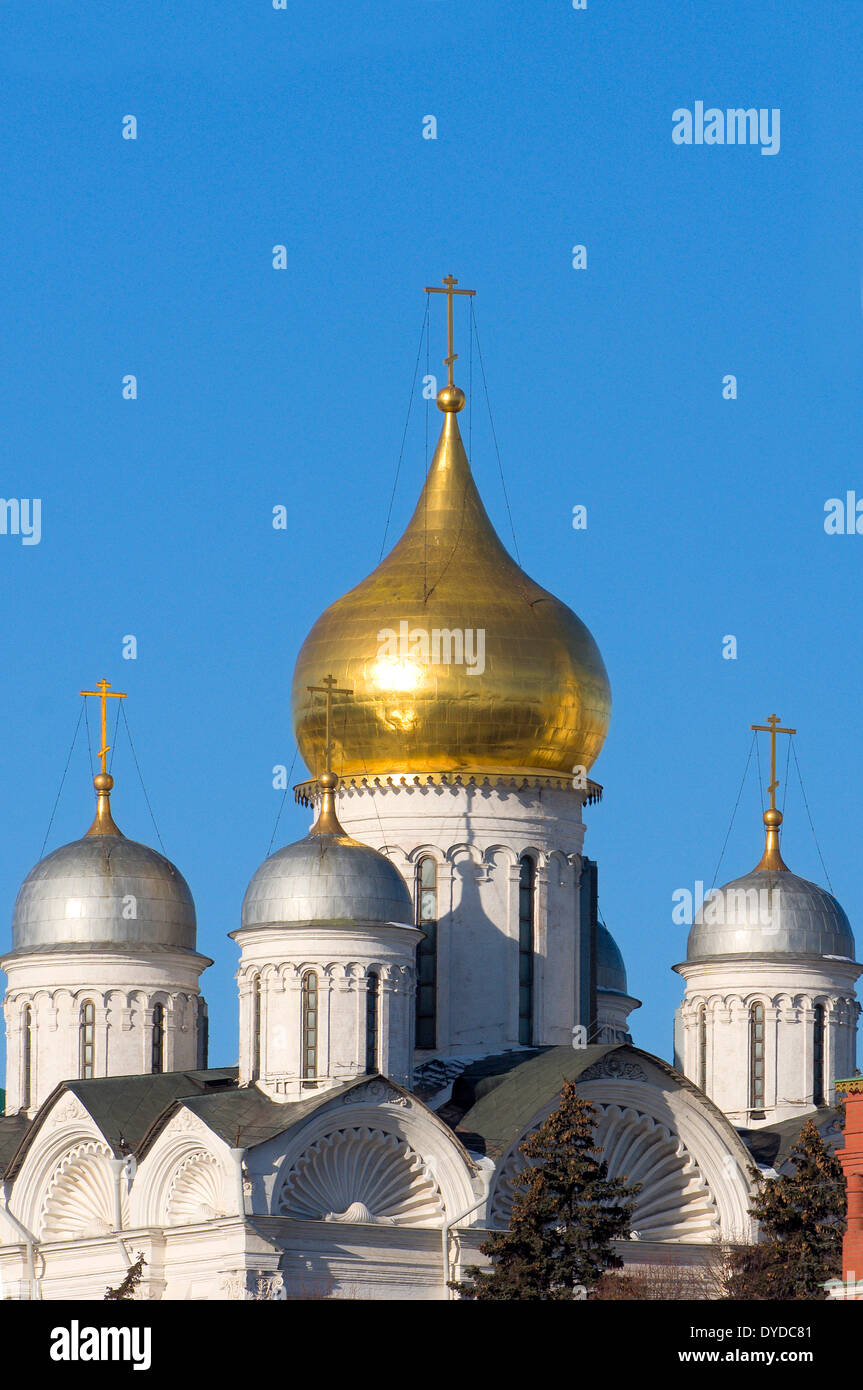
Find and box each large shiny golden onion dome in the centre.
[292,385,611,778]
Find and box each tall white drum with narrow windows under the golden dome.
[326,781,585,1056]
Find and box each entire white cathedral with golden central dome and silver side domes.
[0,277,862,1300]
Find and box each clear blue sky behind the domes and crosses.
[0,0,863,1065]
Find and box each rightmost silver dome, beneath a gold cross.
[687,869,855,960]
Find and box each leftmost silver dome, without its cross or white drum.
[13,834,196,952]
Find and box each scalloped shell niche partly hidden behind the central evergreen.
[492,1101,720,1244]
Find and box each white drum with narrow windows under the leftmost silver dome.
[4,951,210,1115]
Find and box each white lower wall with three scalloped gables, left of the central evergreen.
[0,1077,484,1300]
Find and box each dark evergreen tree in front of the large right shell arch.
[450,1081,641,1300]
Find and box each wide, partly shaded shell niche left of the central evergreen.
[277,1126,443,1227]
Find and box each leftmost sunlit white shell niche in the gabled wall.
[39,1140,126,1241]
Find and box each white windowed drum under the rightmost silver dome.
[677,956,860,1127]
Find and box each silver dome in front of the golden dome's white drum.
[242,833,413,927]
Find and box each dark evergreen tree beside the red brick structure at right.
[727,1119,845,1300]
